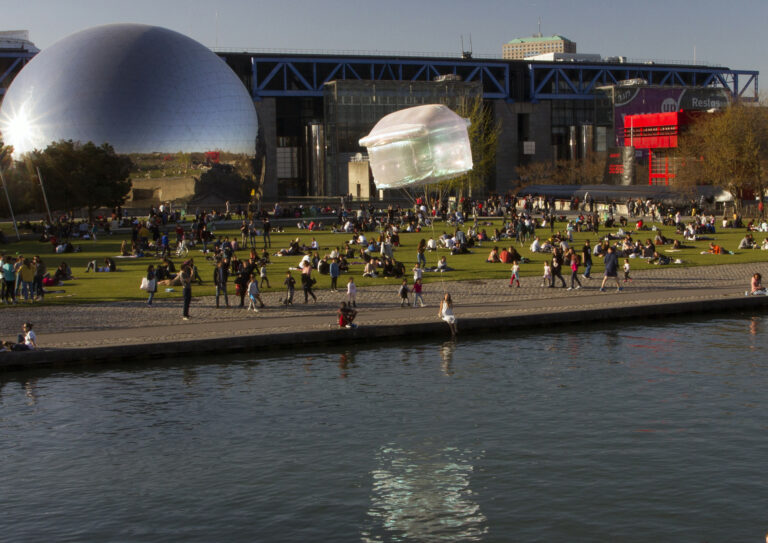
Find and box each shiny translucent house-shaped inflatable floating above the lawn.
[360,104,472,189]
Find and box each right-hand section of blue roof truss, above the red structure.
[527,62,758,102]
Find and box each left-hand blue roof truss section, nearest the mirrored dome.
[251,56,511,100]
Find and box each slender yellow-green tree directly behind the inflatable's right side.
[441,96,501,195]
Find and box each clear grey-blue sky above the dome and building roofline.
[6,0,768,81]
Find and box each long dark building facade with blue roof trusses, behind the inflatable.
[0,29,758,200]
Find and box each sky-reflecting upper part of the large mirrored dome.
[0,24,258,156]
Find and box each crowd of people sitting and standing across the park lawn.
[9,196,768,348]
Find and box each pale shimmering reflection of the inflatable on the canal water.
[360,444,488,542]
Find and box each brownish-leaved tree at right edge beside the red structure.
[676,104,768,205]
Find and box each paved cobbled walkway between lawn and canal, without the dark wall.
[0,263,768,349]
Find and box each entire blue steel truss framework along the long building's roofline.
[238,53,758,102]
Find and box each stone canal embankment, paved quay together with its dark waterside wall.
[0,264,768,370]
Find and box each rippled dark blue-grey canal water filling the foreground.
[0,314,768,542]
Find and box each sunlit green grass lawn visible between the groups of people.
[0,219,768,307]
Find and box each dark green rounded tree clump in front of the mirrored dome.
[27,140,133,219]
